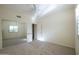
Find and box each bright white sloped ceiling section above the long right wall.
[33,4,76,21]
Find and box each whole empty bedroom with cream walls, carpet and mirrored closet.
[0,4,79,55]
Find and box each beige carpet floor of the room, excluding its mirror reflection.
[0,40,75,55]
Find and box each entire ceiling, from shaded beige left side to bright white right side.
[0,4,74,14]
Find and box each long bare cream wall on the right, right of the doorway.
[37,8,75,48]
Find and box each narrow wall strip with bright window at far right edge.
[75,5,79,55]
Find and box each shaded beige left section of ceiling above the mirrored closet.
[0,4,33,14]
